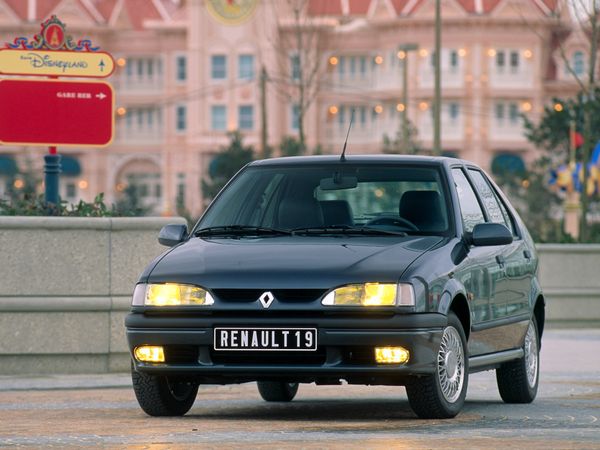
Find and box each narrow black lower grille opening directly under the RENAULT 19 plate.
[210,349,327,365]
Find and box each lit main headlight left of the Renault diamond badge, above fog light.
[132,283,215,306]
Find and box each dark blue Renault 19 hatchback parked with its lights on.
[126,155,544,418]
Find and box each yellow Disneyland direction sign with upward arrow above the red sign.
[0,48,115,78]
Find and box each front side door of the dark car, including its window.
[452,167,508,356]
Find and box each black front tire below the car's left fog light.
[131,368,198,417]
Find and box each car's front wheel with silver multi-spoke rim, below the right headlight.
[406,312,469,419]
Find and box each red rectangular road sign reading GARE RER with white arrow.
[0,79,114,147]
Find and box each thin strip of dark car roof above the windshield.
[249,154,477,167]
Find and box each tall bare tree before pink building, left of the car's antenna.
[269,0,331,149]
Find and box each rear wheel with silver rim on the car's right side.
[496,317,540,403]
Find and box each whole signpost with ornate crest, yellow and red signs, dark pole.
[0,16,115,205]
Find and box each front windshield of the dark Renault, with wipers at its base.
[195,163,450,236]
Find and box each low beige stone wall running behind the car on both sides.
[0,217,600,375]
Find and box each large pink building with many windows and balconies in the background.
[0,0,586,214]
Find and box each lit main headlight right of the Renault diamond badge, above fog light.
[321,283,415,306]
